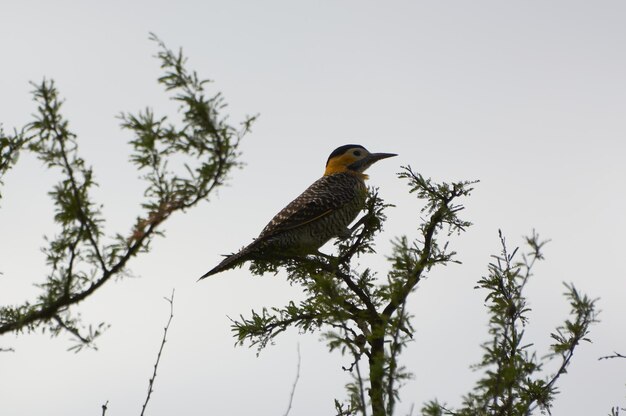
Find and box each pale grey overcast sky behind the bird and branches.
[0,0,626,416]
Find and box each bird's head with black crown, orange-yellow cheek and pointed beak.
[324,144,397,179]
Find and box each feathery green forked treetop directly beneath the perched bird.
[233,168,473,416]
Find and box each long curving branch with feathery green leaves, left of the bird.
[0,35,255,350]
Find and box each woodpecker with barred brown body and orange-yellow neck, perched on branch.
[200,144,397,279]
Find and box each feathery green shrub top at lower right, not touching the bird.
[422,233,597,416]
